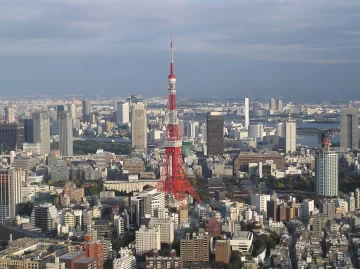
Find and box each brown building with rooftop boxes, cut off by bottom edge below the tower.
[145,249,184,269]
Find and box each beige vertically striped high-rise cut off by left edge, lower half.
[0,168,25,221]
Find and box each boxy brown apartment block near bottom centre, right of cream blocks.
[180,231,210,262]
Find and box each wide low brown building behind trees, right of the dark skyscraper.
[234,151,286,172]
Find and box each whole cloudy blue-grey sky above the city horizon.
[0,0,360,102]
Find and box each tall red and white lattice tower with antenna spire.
[157,37,200,205]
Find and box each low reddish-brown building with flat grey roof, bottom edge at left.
[59,251,98,269]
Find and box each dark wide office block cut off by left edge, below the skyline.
[0,123,24,151]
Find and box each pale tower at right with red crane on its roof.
[315,151,339,196]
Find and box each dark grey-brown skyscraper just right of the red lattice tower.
[206,112,224,156]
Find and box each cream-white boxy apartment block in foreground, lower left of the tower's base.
[135,225,161,255]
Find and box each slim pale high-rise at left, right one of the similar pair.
[57,106,73,156]
